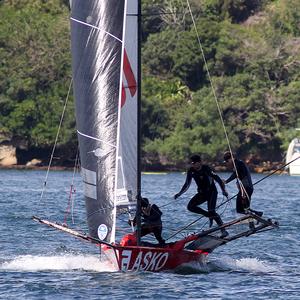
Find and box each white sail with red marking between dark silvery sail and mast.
[116,0,140,213]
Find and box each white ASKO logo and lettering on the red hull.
[120,250,169,271]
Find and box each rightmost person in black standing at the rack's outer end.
[223,151,263,217]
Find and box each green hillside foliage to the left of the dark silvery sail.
[0,0,74,147]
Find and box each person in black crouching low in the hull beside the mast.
[129,198,165,246]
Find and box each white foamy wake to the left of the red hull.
[0,254,117,272]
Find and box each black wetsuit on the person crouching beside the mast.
[134,204,165,244]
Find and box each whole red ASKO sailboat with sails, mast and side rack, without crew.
[33,0,277,272]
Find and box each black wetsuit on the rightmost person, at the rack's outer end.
[226,159,261,214]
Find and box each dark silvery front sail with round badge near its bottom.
[71,0,125,242]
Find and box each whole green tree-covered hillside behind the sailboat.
[0,0,300,166]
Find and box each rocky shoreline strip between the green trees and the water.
[0,132,286,173]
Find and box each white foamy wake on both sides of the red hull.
[0,254,278,275]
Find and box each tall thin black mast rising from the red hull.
[136,0,142,245]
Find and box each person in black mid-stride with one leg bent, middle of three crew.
[174,155,228,238]
